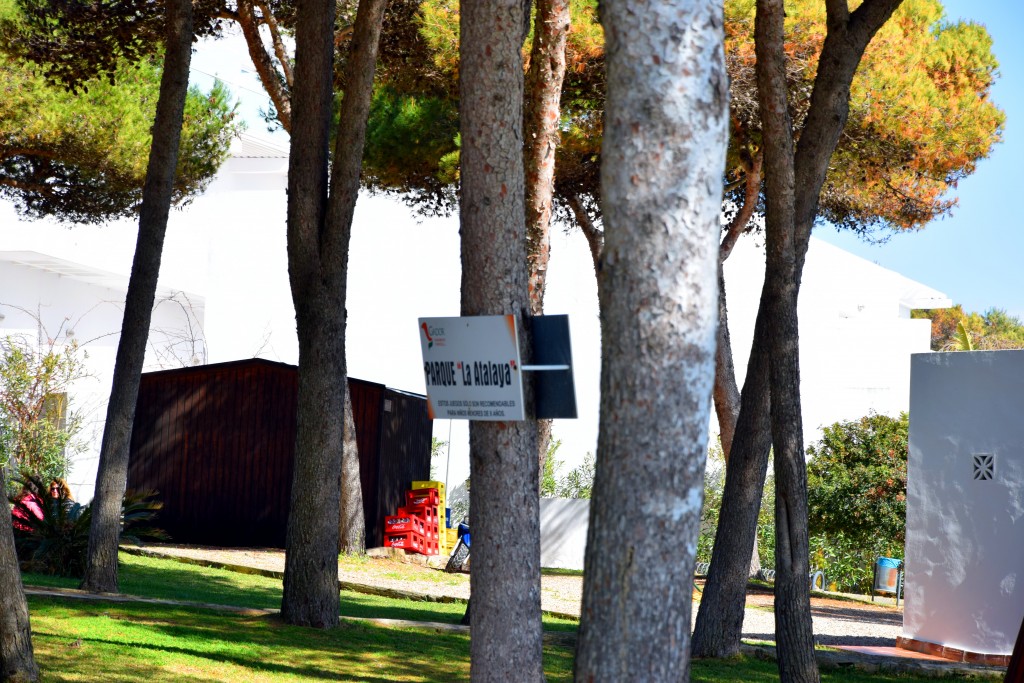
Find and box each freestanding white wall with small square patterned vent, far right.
[903,351,1024,654]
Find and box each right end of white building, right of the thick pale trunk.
[712,237,952,445]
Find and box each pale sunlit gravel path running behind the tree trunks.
[130,545,903,645]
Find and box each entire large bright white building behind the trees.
[0,124,950,507]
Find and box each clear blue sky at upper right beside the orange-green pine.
[815,0,1024,319]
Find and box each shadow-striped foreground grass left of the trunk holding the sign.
[33,599,469,683]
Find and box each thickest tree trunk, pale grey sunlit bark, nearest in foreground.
[575,0,728,681]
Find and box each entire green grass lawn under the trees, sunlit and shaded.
[25,554,987,683]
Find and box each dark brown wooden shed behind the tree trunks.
[128,358,431,548]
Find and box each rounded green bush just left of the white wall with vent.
[807,413,909,592]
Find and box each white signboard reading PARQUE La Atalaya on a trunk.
[420,315,525,422]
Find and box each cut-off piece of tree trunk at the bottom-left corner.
[0,485,39,682]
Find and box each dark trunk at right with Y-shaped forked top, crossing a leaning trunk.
[755,0,900,683]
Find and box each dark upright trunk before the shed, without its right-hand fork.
[281,0,345,628]
